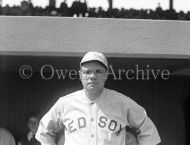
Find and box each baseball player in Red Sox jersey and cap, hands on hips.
[36,52,161,145]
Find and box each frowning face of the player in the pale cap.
[80,61,107,93]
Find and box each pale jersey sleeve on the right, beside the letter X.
[127,100,161,145]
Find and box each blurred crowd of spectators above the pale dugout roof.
[0,0,190,20]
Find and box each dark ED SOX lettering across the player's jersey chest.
[68,116,121,133]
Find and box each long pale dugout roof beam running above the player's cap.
[0,16,190,59]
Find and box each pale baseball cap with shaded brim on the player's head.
[80,51,108,69]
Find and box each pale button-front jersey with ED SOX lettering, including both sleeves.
[36,89,160,145]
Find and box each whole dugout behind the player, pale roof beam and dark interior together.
[0,16,190,145]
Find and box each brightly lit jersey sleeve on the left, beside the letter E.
[35,100,64,145]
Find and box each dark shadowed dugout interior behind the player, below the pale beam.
[0,55,190,145]
